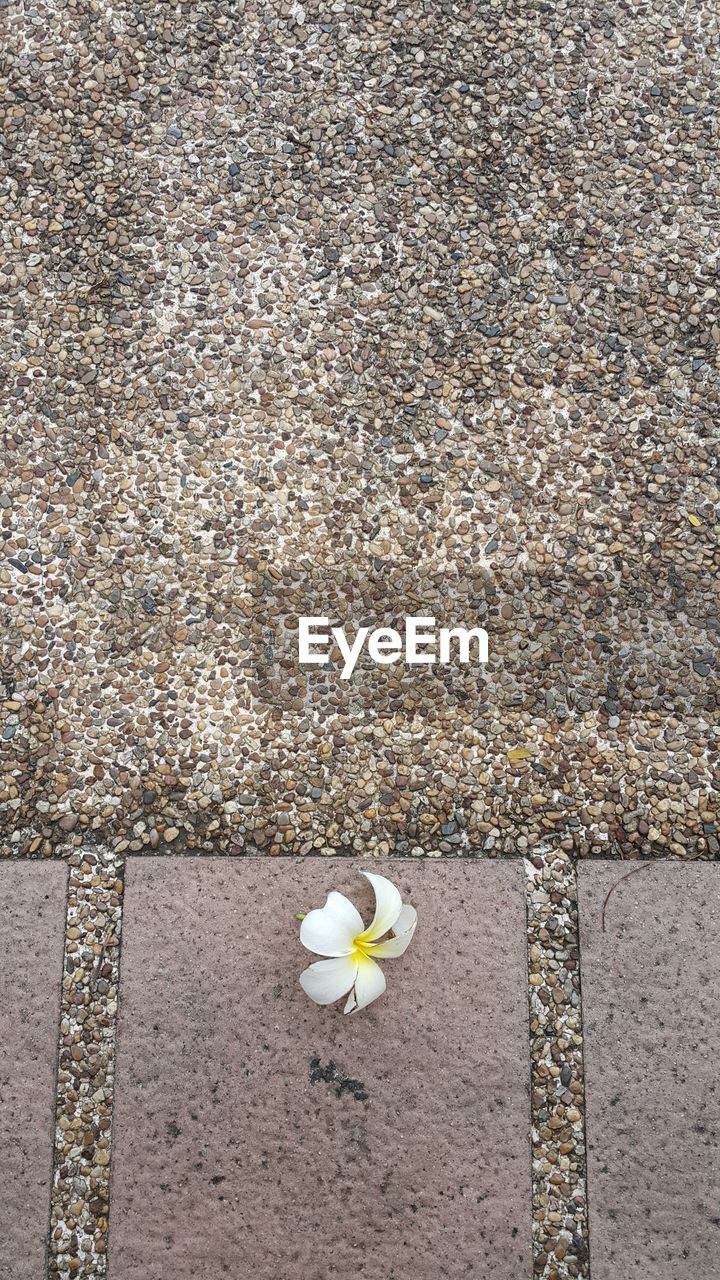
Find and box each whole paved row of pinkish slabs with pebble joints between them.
[0,850,720,1280]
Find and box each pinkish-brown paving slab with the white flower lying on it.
[109,858,532,1280]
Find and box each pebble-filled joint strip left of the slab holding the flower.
[47,847,123,1280]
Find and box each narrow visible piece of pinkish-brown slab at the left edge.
[0,863,67,1280]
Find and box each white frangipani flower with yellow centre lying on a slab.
[300,872,418,1014]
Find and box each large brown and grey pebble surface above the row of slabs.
[0,0,720,858]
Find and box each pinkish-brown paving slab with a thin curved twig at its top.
[579,863,720,1280]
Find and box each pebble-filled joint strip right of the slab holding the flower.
[525,846,589,1280]
